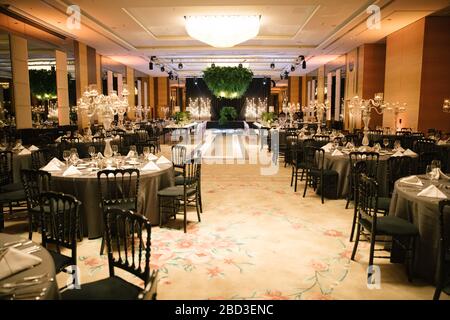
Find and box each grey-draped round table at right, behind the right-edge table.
[324,151,390,198]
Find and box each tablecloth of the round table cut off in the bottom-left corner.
[0,233,60,300]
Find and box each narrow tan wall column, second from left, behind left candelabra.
[55,50,70,126]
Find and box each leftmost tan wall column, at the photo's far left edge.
[10,34,33,129]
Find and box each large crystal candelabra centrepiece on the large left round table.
[77,88,129,131]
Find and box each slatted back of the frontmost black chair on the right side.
[356,173,378,231]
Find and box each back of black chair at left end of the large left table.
[20,169,52,210]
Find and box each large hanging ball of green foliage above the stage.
[203,67,253,99]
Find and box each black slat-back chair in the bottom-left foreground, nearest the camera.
[61,208,158,300]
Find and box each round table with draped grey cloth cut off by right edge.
[389,175,450,283]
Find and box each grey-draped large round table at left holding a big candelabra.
[51,159,175,239]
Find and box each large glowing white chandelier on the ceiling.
[184,15,261,48]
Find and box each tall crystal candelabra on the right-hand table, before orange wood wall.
[349,93,407,146]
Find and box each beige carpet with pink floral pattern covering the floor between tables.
[2,148,449,299]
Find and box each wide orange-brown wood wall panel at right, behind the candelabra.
[383,19,425,130]
